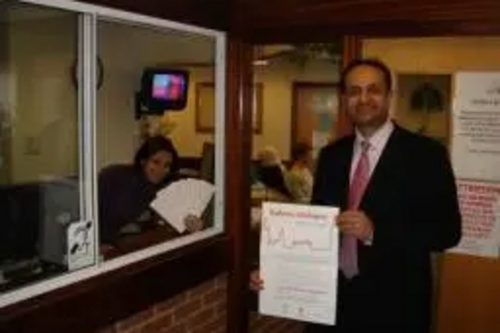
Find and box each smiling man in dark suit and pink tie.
[306,59,461,333]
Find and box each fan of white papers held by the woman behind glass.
[150,179,215,233]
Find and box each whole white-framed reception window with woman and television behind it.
[0,0,225,308]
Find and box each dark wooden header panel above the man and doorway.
[233,0,500,43]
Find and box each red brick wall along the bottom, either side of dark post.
[93,275,302,333]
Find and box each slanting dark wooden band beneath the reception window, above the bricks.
[0,235,229,333]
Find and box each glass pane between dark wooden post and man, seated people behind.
[249,40,341,331]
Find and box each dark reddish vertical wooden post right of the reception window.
[225,35,253,333]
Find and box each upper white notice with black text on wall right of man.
[451,72,500,181]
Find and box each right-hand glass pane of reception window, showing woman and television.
[97,21,216,259]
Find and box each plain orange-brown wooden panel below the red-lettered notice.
[437,254,500,333]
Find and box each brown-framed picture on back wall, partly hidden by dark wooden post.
[195,82,264,134]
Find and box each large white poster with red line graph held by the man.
[259,202,339,325]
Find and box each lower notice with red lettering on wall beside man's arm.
[450,180,500,258]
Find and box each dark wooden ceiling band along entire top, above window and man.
[5,0,500,43]
